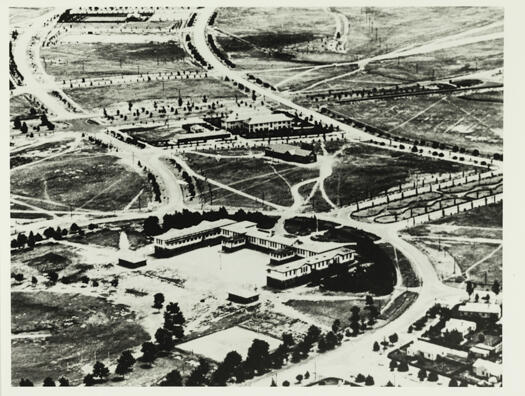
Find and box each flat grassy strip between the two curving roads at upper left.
[41,43,199,81]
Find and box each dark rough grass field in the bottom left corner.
[11,291,149,386]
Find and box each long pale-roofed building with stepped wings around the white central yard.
[154,219,355,289]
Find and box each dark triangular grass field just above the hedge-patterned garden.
[324,144,466,206]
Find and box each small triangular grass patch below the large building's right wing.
[285,298,385,327]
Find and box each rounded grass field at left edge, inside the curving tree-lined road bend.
[11,142,150,211]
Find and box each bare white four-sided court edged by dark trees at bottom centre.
[177,326,281,362]
